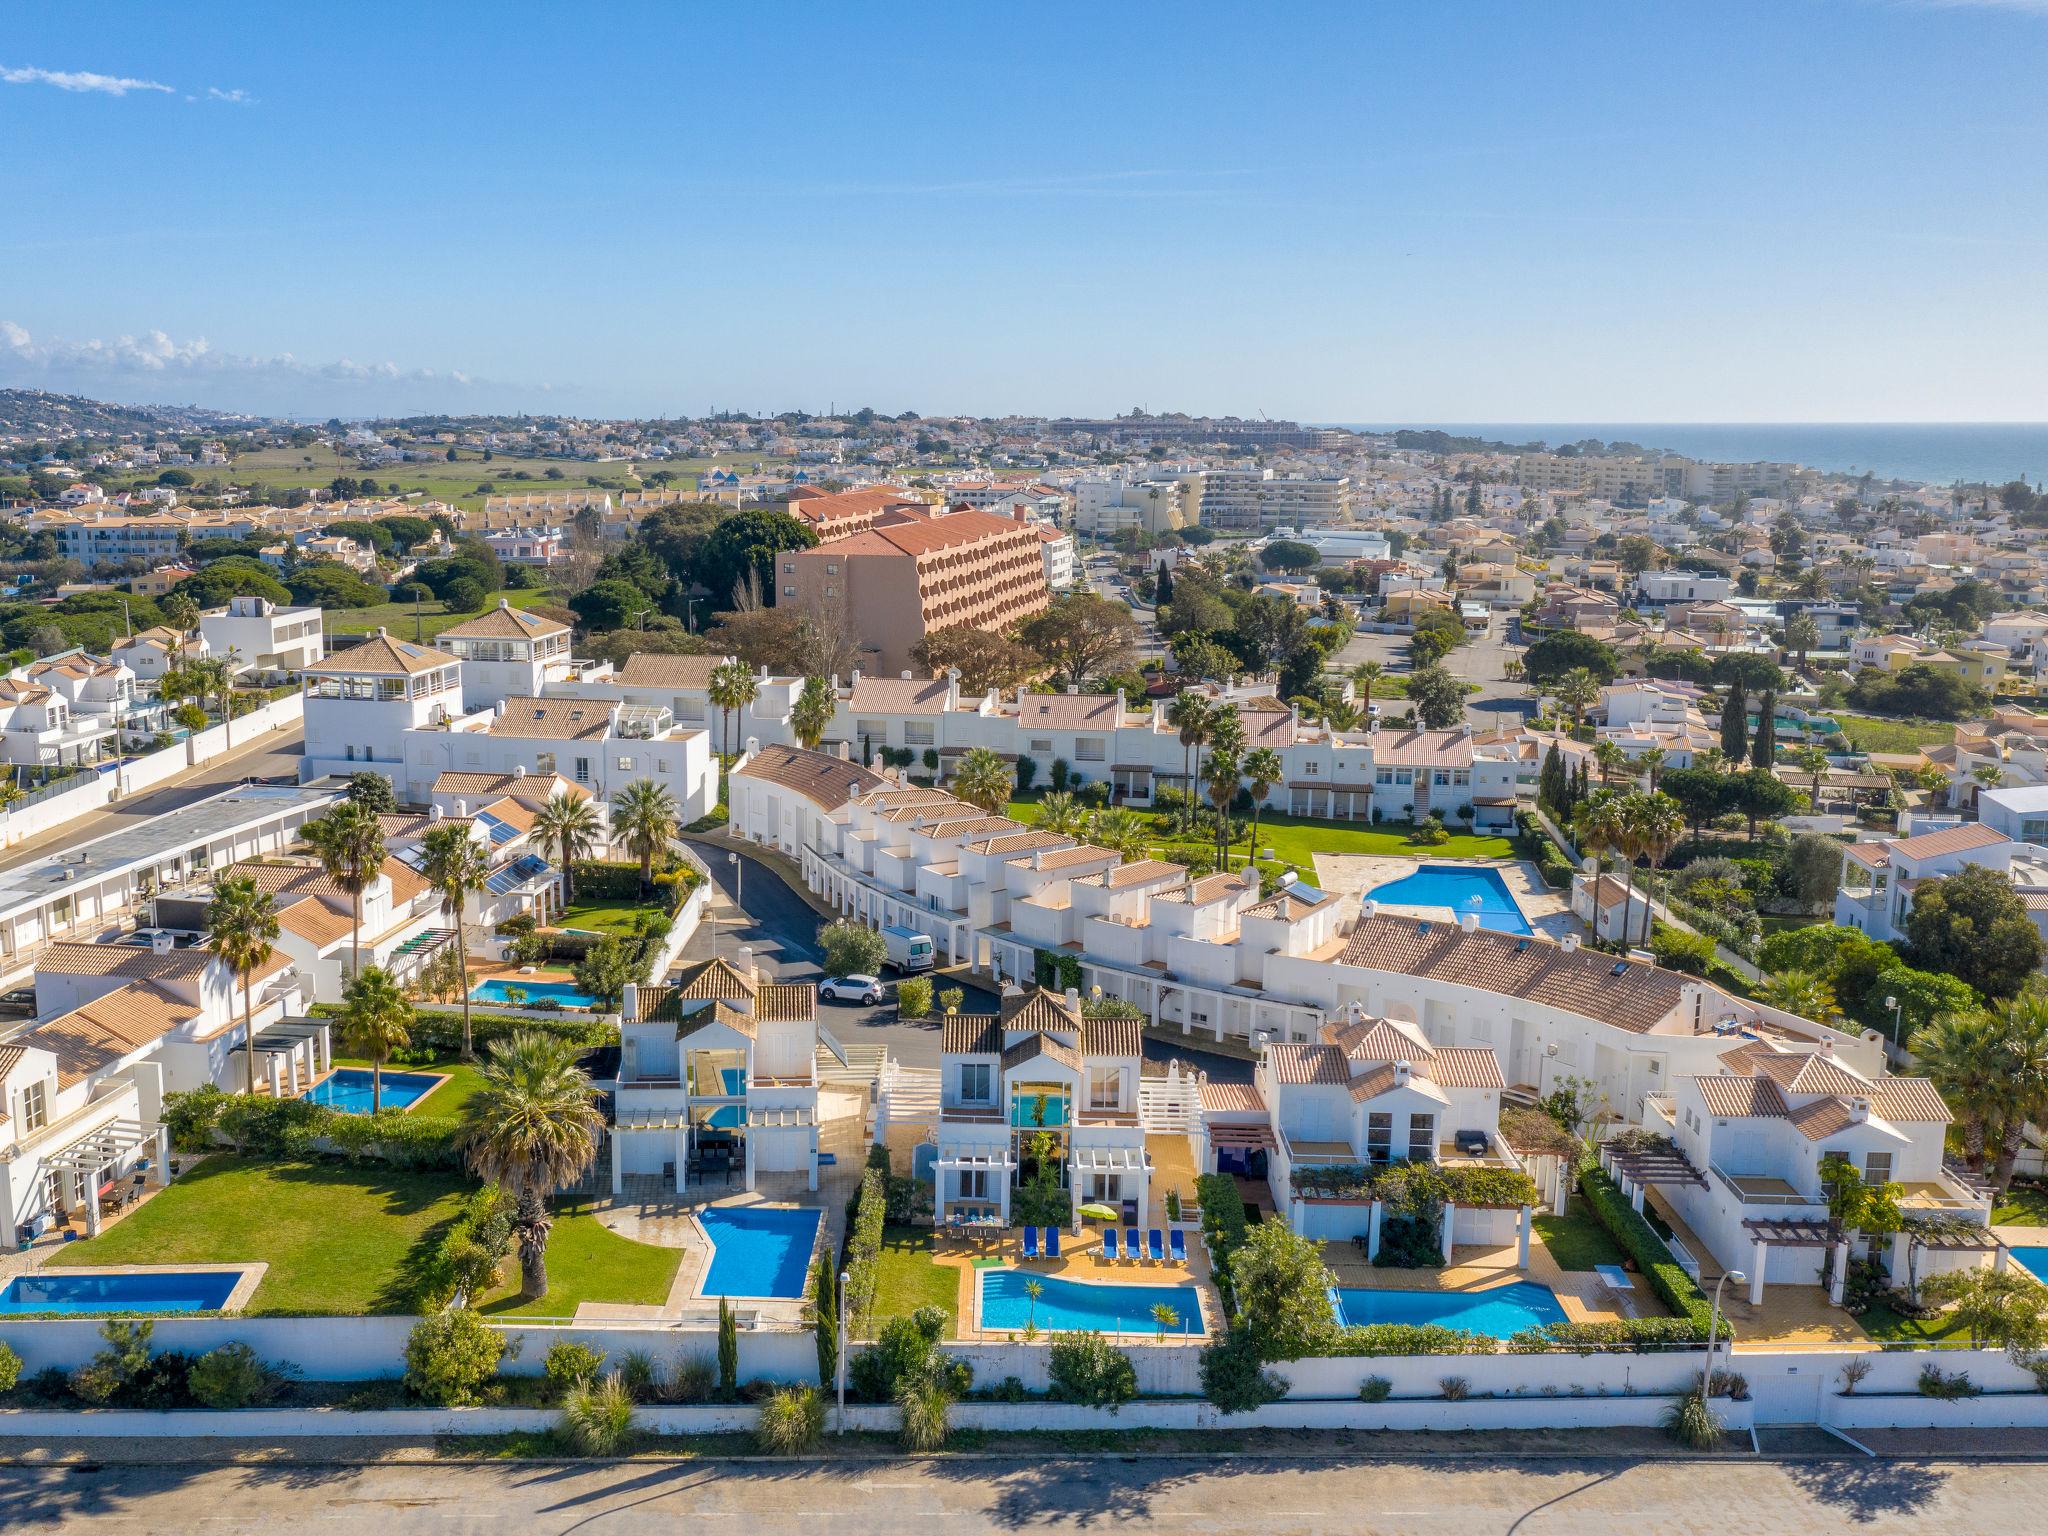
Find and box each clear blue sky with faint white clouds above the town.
[0,0,2048,422]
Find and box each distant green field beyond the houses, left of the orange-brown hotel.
[109,444,788,510]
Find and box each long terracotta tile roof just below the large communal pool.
[1337,915,1683,1034]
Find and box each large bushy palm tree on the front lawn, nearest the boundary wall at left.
[463,1030,604,1300]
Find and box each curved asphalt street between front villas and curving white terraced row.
[682,838,1251,1083]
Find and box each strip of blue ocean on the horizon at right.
[1337,422,2048,485]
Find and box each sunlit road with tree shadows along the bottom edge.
[0,1456,2048,1536]
